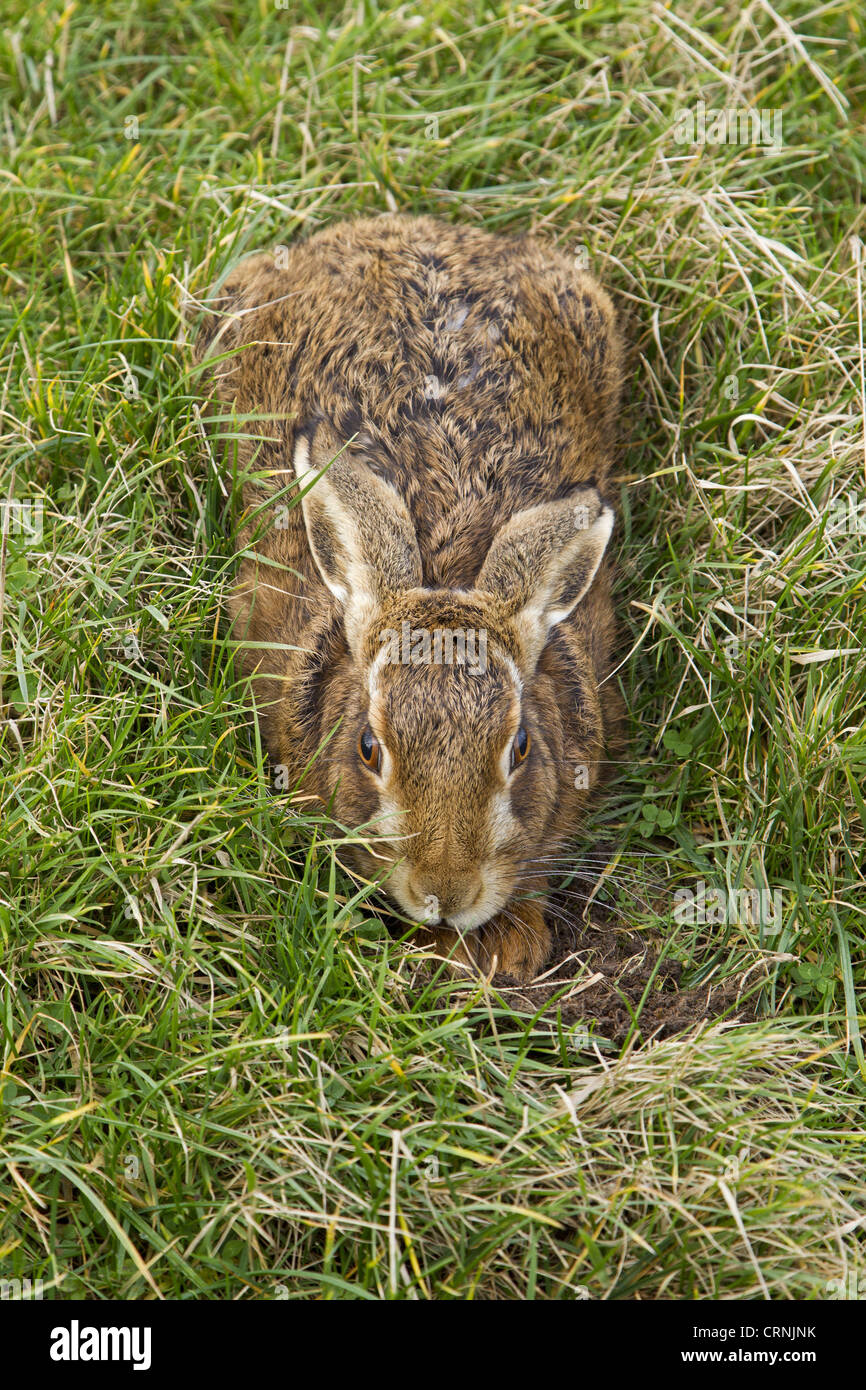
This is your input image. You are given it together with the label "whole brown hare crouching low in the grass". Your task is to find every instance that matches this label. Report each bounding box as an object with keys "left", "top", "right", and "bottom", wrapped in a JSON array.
[{"left": 196, "top": 215, "right": 623, "bottom": 980}]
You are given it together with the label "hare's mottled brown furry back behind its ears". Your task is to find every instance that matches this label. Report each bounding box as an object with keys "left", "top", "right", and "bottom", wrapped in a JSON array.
[{"left": 198, "top": 217, "right": 621, "bottom": 584}]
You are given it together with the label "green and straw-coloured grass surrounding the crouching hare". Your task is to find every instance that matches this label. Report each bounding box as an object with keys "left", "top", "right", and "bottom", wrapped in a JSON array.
[{"left": 0, "top": 0, "right": 866, "bottom": 1300}]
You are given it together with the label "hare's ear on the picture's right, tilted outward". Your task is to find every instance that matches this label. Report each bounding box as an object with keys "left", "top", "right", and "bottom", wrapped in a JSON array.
[{"left": 475, "top": 488, "right": 613, "bottom": 674}]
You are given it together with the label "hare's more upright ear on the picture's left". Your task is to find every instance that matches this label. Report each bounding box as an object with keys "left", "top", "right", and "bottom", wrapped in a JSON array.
[{"left": 293, "top": 423, "right": 421, "bottom": 655}]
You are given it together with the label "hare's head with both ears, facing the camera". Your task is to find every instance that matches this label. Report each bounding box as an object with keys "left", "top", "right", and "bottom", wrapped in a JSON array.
[{"left": 287, "top": 425, "right": 613, "bottom": 930}]
